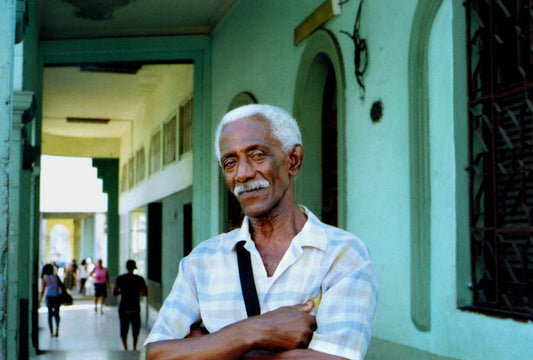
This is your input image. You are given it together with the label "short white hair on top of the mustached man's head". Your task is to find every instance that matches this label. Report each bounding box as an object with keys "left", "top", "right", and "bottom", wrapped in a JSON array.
[{"left": 215, "top": 104, "right": 303, "bottom": 161}]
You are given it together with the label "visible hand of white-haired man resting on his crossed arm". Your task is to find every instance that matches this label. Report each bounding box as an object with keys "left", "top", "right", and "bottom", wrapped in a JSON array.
[{"left": 248, "top": 301, "right": 316, "bottom": 351}]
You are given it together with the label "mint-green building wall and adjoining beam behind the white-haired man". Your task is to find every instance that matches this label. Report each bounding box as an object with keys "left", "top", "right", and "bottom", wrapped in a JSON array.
[{"left": 15, "top": 0, "right": 533, "bottom": 359}]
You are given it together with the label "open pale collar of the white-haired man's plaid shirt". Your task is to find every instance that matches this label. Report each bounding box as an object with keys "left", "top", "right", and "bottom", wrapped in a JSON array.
[{"left": 232, "top": 205, "right": 327, "bottom": 251}]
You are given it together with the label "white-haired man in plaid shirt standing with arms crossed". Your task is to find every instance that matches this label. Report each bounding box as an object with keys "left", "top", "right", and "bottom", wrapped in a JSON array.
[{"left": 145, "top": 104, "right": 377, "bottom": 360}]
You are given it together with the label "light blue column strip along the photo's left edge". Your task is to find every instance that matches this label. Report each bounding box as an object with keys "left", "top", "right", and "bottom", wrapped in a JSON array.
[{"left": 0, "top": 0, "right": 16, "bottom": 359}]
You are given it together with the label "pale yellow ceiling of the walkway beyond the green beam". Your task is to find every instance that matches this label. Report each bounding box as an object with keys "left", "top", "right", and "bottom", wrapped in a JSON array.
[{"left": 42, "top": 65, "right": 179, "bottom": 138}]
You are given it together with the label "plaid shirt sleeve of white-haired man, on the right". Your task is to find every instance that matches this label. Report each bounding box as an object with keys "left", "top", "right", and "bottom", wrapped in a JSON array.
[{"left": 309, "top": 238, "right": 377, "bottom": 359}]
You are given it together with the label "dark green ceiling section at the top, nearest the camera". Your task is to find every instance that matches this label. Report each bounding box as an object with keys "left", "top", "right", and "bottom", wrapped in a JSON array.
[{"left": 37, "top": 0, "right": 238, "bottom": 40}]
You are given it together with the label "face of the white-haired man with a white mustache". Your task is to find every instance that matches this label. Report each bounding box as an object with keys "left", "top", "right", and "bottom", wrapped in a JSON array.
[{"left": 219, "top": 116, "right": 292, "bottom": 217}]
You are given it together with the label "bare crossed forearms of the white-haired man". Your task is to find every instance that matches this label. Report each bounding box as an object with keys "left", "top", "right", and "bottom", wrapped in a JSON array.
[{"left": 146, "top": 301, "right": 350, "bottom": 360}]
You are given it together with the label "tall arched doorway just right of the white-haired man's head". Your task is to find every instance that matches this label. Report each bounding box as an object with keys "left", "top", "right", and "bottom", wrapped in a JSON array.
[{"left": 294, "top": 31, "right": 345, "bottom": 226}]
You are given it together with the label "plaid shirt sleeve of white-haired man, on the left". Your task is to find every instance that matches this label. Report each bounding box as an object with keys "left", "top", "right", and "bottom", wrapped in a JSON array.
[{"left": 144, "top": 258, "right": 200, "bottom": 346}]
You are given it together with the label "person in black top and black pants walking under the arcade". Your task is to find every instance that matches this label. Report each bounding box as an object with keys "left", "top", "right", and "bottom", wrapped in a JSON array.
[{"left": 113, "top": 260, "right": 148, "bottom": 350}]
